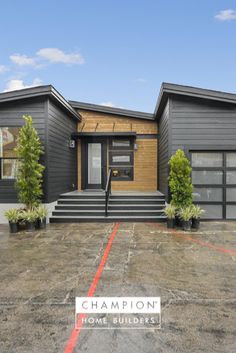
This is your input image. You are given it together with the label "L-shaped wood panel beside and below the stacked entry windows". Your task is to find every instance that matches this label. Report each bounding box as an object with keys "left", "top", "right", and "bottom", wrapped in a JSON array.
[{"left": 112, "top": 139, "right": 157, "bottom": 191}]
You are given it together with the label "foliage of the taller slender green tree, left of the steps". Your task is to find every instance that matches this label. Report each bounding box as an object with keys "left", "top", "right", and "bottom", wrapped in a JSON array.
[{"left": 16, "top": 115, "right": 44, "bottom": 209}]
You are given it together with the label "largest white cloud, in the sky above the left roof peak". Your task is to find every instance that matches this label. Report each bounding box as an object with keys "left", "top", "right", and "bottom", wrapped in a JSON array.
[{"left": 36, "top": 48, "right": 84, "bottom": 64}]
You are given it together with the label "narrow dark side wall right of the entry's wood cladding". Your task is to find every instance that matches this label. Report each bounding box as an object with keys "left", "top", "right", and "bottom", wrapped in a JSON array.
[{"left": 158, "top": 101, "right": 169, "bottom": 195}]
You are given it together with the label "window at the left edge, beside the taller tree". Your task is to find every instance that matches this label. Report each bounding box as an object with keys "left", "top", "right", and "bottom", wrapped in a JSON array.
[{"left": 0, "top": 127, "right": 20, "bottom": 179}]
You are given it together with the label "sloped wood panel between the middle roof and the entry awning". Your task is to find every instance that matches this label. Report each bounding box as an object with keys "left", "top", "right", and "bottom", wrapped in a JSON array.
[{"left": 78, "top": 110, "right": 158, "bottom": 134}]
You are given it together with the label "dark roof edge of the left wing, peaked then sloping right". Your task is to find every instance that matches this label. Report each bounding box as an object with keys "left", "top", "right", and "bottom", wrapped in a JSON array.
[{"left": 0, "top": 85, "right": 81, "bottom": 121}]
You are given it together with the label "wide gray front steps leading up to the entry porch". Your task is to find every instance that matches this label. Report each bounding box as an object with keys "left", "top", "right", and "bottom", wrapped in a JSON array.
[{"left": 50, "top": 192, "right": 166, "bottom": 223}]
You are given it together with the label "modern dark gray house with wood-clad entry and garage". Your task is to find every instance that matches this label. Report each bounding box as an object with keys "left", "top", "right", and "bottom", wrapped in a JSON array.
[{"left": 0, "top": 83, "right": 236, "bottom": 222}]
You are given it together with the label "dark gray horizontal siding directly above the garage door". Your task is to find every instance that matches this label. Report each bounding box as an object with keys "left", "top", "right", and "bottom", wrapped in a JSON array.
[{"left": 170, "top": 96, "right": 236, "bottom": 153}]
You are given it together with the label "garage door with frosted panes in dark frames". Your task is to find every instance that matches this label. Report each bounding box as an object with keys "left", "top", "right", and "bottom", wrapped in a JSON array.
[{"left": 191, "top": 151, "right": 236, "bottom": 219}]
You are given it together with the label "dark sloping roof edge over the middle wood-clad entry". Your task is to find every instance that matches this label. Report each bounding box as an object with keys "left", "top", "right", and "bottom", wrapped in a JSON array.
[{"left": 69, "top": 100, "right": 155, "bottom": 120}]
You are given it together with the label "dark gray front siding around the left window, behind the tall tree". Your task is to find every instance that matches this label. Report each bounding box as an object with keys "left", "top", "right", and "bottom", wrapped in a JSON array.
[{"left": 0, "top": 98, "right": 45, "bottom": 203}]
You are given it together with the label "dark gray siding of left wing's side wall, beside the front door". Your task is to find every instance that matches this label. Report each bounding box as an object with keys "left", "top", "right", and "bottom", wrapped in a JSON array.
[{"left": 46, "top": 101, "right": 77, "bottom": 202}]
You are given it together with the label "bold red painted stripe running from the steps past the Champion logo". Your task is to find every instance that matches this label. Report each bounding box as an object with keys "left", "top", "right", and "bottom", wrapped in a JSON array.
[{"left": 64, "top": 223, "right": 119, "bottom": 353}]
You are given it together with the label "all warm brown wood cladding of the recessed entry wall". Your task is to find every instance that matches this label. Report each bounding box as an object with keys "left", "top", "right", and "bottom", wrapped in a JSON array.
[{"left": 78, "top": 111, "right": 158, "bottom": 191}]
